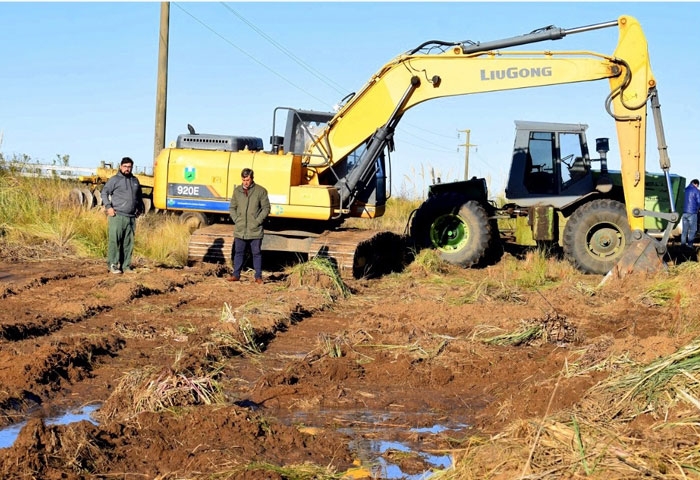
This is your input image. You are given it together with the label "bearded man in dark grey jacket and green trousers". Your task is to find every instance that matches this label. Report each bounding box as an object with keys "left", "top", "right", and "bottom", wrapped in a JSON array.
[{"left": 102, "top": 157, "right": 145, "bottom": 274}]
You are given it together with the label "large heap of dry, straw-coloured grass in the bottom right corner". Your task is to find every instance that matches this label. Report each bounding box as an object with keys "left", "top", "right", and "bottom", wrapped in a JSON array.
[{"left": 440, "top": 339, "right": 700, "bottom": 480}]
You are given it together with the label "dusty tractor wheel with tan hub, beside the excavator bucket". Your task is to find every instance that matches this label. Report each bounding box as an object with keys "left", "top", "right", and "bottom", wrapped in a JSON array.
[{"left": 563, "top": 199, "right": 632, "bottom": 275}]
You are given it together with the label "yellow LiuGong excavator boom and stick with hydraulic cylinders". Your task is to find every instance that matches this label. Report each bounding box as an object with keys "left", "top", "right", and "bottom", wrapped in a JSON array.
[{"left": 307, "top": 16, "right": 674, "bottom": 238}]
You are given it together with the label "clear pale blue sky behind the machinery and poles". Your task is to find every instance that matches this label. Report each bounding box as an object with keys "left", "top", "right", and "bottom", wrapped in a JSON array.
[{"left": 0, "top": 2, "right": 700, "bottom": 196}]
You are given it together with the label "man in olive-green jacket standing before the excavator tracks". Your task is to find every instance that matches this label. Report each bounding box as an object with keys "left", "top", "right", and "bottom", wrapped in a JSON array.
[{"left": 228, "top": 168, "right": 270, "bottom": 283}]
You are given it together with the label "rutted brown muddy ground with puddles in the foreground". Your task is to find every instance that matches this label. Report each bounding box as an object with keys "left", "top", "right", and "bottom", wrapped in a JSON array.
[{"left": 0, "top": 246, "right": 690, "bottom": 479}]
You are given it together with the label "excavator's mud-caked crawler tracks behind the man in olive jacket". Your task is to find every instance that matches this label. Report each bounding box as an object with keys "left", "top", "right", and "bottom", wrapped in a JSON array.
[{"left": 188, "top": 224, "right": 406, "bottom": 278}]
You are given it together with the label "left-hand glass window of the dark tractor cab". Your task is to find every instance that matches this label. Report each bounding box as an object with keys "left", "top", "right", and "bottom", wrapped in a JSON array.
[{"left": 525, "top": 132, "right": 556, "bottom": 194}]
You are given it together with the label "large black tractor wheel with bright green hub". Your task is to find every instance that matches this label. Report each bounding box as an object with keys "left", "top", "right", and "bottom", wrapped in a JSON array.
[{"left": 411, "top": 193, "right": 491, "bottom": 267}]
